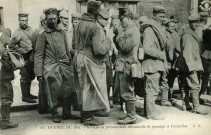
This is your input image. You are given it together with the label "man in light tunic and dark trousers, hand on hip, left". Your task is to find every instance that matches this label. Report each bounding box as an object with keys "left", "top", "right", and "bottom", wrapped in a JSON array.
[{"left": 9, "top": 13, "right": 38, "bottom": 103}]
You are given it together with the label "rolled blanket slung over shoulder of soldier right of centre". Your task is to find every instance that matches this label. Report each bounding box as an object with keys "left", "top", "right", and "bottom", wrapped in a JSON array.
[{"left": 141, "top": 20, "right": 166, "bottom": 50}]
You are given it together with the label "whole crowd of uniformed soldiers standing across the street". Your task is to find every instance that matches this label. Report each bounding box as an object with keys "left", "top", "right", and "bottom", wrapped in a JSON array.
[{"left": 0, "top": 0, "right": 211, "bottom": 129}]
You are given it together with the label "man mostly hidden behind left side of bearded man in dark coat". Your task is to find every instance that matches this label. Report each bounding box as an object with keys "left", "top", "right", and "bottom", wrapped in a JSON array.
[{"left": 32, "top": 14, "right": 49, "bottom": 114}]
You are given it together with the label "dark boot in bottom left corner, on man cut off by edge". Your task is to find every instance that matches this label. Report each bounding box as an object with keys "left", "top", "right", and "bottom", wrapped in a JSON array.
[{"left": 0, "top": 105, "right": 18, "bottom": 129}]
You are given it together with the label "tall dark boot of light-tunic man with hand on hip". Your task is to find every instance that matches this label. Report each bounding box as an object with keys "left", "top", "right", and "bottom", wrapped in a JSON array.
[{"left": 20, "top": 80, "right": 36, "bottom": 103}]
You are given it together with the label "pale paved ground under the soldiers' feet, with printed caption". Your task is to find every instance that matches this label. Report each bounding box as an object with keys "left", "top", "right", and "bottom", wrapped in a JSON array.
[{"left": 0, "top": 70, "right": 211, "bottom": 135}]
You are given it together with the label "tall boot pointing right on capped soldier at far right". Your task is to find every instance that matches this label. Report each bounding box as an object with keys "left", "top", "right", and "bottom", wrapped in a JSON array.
[{"left": 192, "top": 91, "right": 208, "bottom": 115}]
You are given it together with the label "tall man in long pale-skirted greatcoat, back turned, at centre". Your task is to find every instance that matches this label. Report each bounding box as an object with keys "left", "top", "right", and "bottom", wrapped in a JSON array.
[{"left": 73, "top": 0, "right": 111, "bottom": 126}]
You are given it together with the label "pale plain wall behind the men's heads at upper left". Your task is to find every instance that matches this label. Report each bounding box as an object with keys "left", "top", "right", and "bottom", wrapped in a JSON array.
[{"left": 0, "top": 0, "right": 76, "bottom": 32}]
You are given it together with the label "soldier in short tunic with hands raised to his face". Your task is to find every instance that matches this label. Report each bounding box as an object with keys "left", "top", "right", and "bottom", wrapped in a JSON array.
[{"left": 114, "top": 8, "right": 140, "bottom": 124}]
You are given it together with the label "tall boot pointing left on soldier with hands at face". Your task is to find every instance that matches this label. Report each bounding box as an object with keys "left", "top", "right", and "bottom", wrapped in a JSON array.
[{"left": 118, "top": 101, "right": 136, "bottom": 125}]
